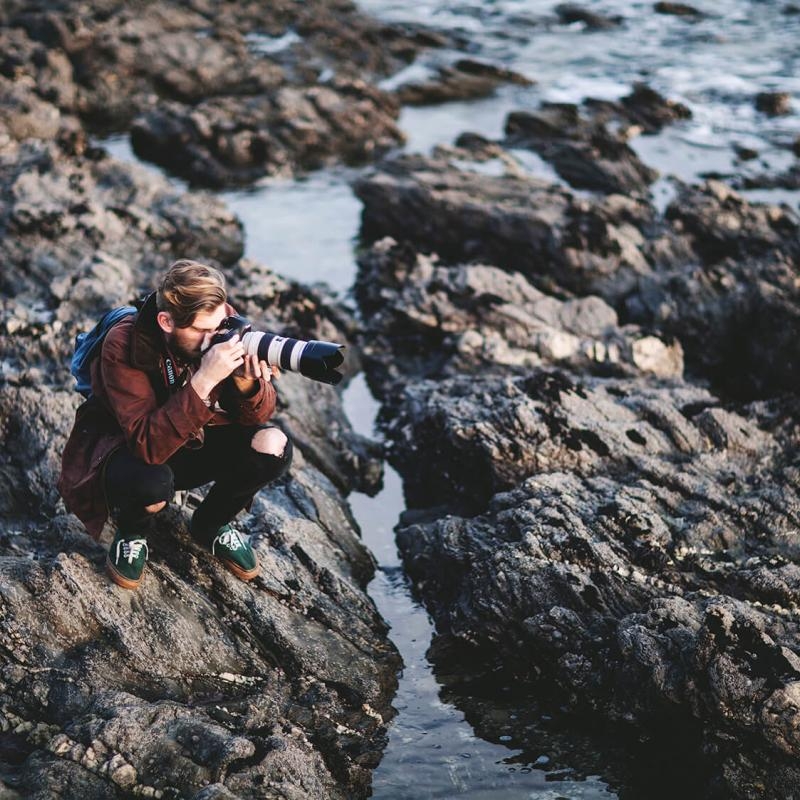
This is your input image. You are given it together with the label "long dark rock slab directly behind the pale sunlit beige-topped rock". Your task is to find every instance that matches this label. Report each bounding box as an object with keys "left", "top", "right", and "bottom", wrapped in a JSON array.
[{"left": 355, "top": 157, "right": 654, "bottom": 296}]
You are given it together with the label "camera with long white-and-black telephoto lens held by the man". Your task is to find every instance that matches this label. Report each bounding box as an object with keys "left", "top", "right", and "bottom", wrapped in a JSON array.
[{"left": 209, "top": 315, "right": 344, "bottom": 386}]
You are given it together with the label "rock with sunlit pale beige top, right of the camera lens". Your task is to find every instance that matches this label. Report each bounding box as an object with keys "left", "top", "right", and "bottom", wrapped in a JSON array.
[{"left": 356, "top": 239, "right": 683, "bottom": 396}]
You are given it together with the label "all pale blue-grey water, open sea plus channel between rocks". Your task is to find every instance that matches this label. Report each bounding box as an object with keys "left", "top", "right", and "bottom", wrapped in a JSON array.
[{"left": 104, "top": 0, "right": 800, "bottom": 800}]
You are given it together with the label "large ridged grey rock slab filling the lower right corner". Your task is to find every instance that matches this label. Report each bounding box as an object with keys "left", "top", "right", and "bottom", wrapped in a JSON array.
[{"left": 398, "top": 446, "right": 800, "bottom": 797}]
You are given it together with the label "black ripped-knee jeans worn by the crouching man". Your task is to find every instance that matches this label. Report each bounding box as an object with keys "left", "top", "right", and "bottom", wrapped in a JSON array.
[{"left": 104, "top": 425, "right": 292, "bottom": 538}]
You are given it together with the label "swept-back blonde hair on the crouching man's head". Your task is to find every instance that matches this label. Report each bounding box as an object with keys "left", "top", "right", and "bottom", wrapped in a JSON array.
[{"left": 156, "top": 258, "right": 228, "bottom": 328}]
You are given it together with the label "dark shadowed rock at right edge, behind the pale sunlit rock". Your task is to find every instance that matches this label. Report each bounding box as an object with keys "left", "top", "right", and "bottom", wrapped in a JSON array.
[{"left": 636, "top": 182, "right": 800, "bottom": 398}]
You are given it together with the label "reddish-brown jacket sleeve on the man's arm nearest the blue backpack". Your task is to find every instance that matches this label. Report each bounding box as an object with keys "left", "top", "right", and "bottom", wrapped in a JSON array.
[{"left": 100, "top": 326, "right": 214, "bottom": 464}]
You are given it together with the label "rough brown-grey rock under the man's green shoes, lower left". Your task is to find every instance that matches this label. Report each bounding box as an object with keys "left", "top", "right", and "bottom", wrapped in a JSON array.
[{"left": 0, "top": 432, "right": 398, "bottom": 798}]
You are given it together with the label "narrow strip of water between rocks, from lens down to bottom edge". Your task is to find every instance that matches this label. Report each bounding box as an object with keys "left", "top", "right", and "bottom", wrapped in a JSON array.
[{"left": 344, "top": 376, "right": 614, "bottom": 800}]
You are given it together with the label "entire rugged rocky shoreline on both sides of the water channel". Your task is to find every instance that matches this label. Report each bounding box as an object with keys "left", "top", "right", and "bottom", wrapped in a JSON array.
[{"left": 0, "top": 0, "right": 800, "bottom": 800}]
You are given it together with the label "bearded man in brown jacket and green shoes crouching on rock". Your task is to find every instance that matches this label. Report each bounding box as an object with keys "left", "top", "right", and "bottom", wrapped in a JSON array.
[{"left": 58, "top": 260, "right": 292, "bottom": 589}]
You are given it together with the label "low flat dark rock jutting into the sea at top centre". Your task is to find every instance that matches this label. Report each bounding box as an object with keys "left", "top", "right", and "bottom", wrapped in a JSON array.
[{"left": 396, "top": 59, "right": 533, "bottom": 106}]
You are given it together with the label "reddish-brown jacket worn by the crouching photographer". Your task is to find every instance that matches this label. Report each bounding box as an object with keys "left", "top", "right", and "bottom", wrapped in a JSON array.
[{"left": 58, "top": 294, "right": 275, "bottom": 539}]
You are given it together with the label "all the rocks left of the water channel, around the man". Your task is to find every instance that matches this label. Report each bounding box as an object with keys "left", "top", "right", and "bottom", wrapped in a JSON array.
[{"left": 0, "top": 2, "right": 412, "bottom": 800}]
